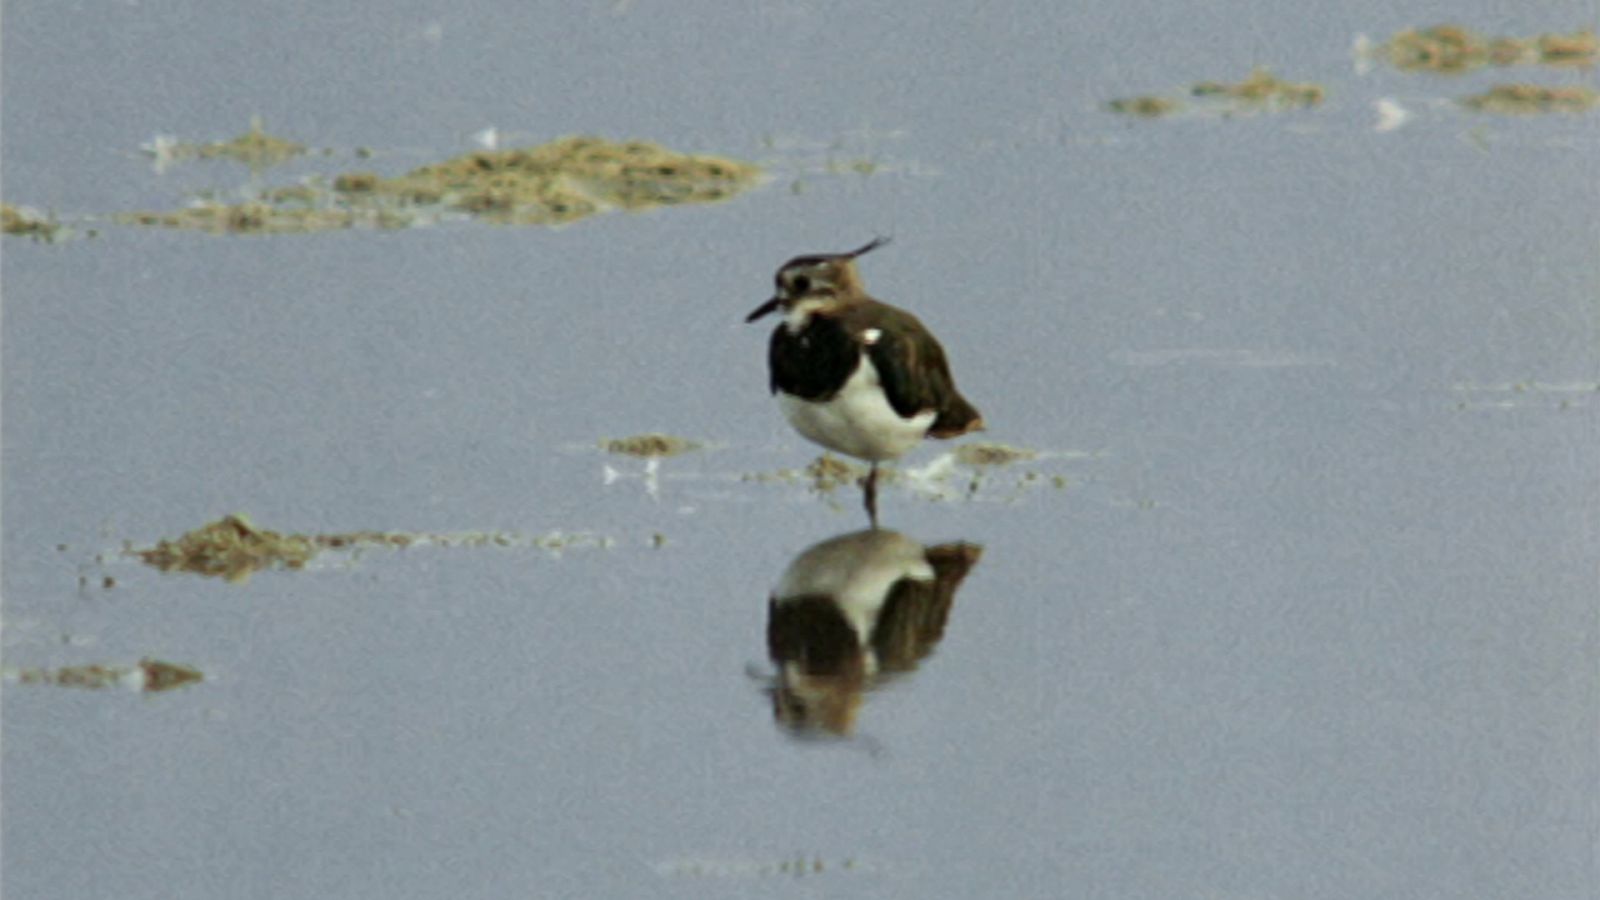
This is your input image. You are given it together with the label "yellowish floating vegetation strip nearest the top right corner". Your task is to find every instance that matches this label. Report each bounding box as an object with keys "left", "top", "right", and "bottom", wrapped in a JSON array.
[{"left": 1378, "top": 24, "right": 1600, "bottom": 72}]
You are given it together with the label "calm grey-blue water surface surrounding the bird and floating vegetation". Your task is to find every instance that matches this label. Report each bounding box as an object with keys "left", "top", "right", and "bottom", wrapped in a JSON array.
[{"left": 0, "top": 0, "right": 1600, "bottom": 900}]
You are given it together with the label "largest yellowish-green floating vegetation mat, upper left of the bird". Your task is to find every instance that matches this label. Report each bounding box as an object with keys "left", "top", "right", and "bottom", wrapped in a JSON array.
[{"left": 117, "top": 135, "right": 762, "bottom": 234}]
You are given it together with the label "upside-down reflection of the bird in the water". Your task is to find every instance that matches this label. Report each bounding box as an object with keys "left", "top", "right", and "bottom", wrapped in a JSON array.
[{"left": 766, "top": 528, "right": 982, "bottom": 737}]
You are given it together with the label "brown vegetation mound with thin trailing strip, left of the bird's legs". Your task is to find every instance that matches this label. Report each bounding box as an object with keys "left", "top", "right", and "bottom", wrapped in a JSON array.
[{"left": 131, "top": 514, "right": 613, "bottom": 583}]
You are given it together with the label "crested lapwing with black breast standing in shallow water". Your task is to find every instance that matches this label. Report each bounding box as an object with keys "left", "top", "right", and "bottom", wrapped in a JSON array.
[{"left": 744, "top": 237, "right": 984, "bottom": 527}]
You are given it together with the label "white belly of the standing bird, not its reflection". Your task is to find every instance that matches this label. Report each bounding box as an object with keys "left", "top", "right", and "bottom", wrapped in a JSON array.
[{"left": 778, "top": 356, "right": 938, "bottom": 463}]
